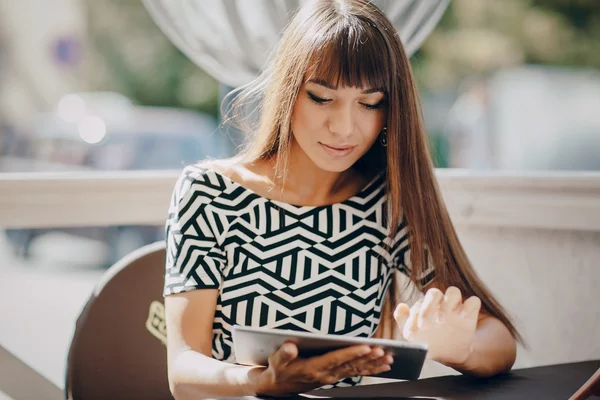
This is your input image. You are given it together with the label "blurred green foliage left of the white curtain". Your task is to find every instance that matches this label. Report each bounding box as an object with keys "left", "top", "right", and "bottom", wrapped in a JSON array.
[{"left": 82, "top": 0, "right": 219, "bottom": 116}]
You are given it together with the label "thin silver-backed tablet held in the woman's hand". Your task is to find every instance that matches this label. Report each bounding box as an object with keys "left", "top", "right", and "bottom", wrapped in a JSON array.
[{"left": 232, "top": 325, "right": 427, "bottom": 380}]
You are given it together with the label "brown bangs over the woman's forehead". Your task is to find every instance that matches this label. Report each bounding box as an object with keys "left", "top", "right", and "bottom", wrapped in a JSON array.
[{"left": 307, "top": 17, "right": 392, "bottom": 92}]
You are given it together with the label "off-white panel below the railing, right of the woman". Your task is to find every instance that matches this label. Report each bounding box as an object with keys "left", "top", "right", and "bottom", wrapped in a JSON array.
[{"left": 423, "top": 226, "right": 600, "bottom": 376}]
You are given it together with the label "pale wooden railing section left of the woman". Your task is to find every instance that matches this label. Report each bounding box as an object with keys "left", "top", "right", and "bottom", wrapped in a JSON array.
[{"left": 0, "top": 171, "right": 179, "bottom": 228}]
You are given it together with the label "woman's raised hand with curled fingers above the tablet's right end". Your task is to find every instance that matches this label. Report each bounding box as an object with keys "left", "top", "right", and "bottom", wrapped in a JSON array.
[{"left": 394, "top": 286, "right": 481, "bottom": 366}]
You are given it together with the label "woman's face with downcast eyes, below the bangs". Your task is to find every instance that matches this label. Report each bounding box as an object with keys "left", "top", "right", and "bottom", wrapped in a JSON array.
[{"left": 292, "top": 76, "right": 387, "bottom": 172}]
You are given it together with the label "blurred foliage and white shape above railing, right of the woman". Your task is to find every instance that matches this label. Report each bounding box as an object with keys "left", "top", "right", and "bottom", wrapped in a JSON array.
[{"left": 413, "top": 0, "right": 600, "bottom": 170}]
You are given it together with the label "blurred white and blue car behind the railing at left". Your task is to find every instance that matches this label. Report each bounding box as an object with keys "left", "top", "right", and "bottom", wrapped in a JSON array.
[{"left": 6, "top": 93, "right": 234, "bottom": 267}]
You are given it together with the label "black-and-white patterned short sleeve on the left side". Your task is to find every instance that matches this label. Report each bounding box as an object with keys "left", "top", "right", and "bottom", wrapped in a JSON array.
[{"left": 163, "top": 167, "right": 226, "bottom": 296}]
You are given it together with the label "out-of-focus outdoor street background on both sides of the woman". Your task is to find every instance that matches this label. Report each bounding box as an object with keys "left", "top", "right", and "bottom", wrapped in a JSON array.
[{"left": 0, "top": 0, "right": 600, "bottom": 398}]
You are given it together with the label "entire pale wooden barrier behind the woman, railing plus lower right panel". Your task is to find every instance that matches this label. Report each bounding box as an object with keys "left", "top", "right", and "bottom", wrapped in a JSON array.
[{"left": 0, "top": 170, "right": 600, "bottom": 377}]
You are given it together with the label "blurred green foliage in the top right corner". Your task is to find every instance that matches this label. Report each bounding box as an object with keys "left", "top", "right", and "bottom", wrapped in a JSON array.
[{"left": 413, "top": 0, "right": 600, "bottom": 90}]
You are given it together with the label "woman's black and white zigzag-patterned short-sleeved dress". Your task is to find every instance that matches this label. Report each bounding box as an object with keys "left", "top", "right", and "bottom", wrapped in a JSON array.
[{"left": 164, "top": 166, "right": 428, "bottom": 386}]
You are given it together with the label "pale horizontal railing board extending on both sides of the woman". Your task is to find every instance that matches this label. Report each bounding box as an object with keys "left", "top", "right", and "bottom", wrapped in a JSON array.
[{"left": 0, "top": 169, "right": 600, "bottom": 231}]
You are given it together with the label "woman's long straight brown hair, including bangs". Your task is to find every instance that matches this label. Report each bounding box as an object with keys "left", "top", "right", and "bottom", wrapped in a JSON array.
[{"left": 223, "top": 0, "right": 522, "bottom": 342}]
